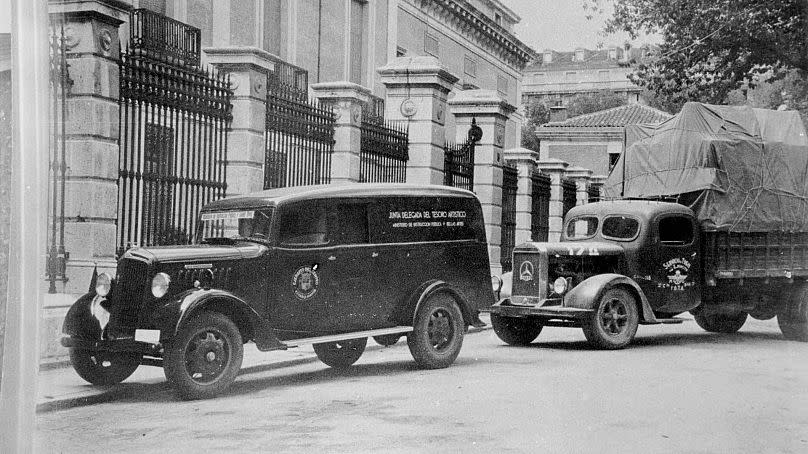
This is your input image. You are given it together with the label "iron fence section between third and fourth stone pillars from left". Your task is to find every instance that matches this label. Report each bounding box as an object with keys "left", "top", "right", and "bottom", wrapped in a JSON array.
[{"left": 359, "top": 96, "right": 410, "bottom": 183}]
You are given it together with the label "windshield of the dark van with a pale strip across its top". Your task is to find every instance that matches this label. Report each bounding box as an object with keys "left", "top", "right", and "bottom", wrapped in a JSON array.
[{"left": 197, "top": 208, "right": 272, "bottom": 243}]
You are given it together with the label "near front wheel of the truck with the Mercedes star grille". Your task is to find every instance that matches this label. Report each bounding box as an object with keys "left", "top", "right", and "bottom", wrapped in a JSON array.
[{"left": 583, "top": 288, "right": 640, "bottom": 350}]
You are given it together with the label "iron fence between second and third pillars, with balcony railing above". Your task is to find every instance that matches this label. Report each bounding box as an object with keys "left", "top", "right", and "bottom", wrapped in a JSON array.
[{"left": 264, "top": 60, "right": 336, "bottom": 189}]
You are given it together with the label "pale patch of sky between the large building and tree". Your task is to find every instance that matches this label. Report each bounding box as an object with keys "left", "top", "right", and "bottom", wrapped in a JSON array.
[{"left": 501, "top": 0, "right": 655, "bottom": 52}]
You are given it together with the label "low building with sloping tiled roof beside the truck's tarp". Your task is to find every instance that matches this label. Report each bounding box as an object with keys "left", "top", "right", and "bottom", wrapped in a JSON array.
[{"left": 536, "top": 103, "right": 672, "bottom": 175}]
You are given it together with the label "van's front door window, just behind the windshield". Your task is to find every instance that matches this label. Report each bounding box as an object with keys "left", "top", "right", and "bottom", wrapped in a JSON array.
[{"left": 279, "top": 202, "right": 329, "bottom": 246}]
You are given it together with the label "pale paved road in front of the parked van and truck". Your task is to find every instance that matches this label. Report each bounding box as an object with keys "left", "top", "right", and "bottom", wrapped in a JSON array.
[{"left": 36, "top": 319, "right": 808, "bottom": 453}]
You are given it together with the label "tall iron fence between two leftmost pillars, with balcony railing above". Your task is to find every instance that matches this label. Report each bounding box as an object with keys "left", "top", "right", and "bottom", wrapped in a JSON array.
[{"left": 117, "top": 9, "right": 233, "bottom": 255}]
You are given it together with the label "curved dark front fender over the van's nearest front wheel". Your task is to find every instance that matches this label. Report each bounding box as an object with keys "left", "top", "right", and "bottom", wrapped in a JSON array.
[{"left": 152, "top": 289, "right": 286, "bottom": 351}]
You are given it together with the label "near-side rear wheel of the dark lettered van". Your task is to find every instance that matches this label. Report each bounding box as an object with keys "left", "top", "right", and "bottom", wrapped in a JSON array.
[{"left": 407, "top": 293, "right": 465, "bottom": 369}]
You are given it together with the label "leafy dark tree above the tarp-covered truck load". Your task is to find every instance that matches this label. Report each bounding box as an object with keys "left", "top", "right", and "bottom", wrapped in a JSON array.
[{"left": 584, "top": 0, "right": 808, "bottom": 105}]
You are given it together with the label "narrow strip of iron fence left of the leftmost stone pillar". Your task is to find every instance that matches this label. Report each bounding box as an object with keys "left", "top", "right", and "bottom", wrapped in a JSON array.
[{"left": 46, "top": 24, "right": 73, "bottom": 293}]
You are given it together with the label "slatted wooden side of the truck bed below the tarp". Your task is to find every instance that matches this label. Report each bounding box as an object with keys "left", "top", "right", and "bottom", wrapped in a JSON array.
[{"left": 702, "top": 232, "right": 808, "bottom": 279}]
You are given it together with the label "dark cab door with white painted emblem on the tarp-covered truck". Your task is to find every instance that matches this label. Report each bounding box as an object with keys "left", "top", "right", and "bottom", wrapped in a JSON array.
[{"left": 644, "top": 214, "right": 701, "bottom": 314}]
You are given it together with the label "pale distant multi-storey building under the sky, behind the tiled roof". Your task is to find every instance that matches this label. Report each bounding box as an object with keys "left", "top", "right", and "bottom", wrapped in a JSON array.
[{"left": 522, "top": 45, "right": 654, "bottom": 106}]
